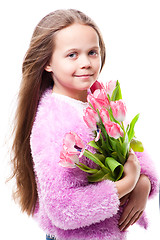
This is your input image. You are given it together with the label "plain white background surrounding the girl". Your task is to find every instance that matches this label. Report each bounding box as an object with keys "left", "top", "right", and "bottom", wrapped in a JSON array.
[{"left": 0, "top": 0, "right": 160, "bottom": 240}]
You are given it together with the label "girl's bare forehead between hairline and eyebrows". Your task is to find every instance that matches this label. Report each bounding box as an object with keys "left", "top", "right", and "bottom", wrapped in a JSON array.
[{"left": 55, "top": 23, "right": 99, "bottom": 49}]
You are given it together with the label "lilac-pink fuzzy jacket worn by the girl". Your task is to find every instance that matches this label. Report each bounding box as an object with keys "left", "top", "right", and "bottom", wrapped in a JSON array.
[{"left": 30, "top": 90, "right": 158, "bottom": 240}]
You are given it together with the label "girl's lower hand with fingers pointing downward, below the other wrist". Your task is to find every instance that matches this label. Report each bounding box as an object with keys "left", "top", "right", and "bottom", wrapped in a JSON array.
[{"left": 119, "top": 175, "right": 151, "bottom": 231}]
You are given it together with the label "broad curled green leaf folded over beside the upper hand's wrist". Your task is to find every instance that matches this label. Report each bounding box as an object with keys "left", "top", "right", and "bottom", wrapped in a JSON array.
[{"left": 105, "top": 157, "right": 123, "bottom": 181}]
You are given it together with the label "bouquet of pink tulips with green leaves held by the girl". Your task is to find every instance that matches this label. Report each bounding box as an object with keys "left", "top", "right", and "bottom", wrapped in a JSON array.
[{"left": 59, "top": 81, "right": 144, "bottom": 182}]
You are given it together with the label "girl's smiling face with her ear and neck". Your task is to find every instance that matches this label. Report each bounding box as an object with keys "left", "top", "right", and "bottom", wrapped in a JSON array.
[{"left": 45, "top": 23, "right": 101, "bottom": 101}]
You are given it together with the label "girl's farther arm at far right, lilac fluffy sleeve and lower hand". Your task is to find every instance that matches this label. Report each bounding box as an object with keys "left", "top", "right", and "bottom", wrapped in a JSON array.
[{"left": 119, "top": 152, "right": 158, "bottom": 230}]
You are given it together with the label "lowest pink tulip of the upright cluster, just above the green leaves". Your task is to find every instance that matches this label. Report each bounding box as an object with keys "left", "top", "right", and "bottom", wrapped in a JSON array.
[{"left": 104, "top": 121, "right": 123, "bottom": 139}]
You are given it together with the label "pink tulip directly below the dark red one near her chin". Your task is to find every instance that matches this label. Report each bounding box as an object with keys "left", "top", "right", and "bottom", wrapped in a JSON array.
[{"left": 87, "top": 89, "right": 109, "bottom": 110}]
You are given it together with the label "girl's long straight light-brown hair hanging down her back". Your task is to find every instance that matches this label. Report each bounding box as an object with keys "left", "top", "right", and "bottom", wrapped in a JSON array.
[{"left": 12, "top": 9, "right": 105, "bottom": 215}]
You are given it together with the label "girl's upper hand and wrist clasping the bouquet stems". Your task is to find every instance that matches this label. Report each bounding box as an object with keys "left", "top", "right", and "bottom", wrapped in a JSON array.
[{"left": 115, "top": 152, "right": 140, "bottom": 199}]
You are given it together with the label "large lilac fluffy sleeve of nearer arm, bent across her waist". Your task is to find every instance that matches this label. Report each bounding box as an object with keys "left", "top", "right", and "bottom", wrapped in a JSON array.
[{"left": 30, "top": 92, "right": 119, "bottom": 230}]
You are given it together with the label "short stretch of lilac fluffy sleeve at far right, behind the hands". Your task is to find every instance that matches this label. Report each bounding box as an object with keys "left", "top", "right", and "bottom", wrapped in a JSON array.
[{"left": 136, "top": 150, "right": 158, "bottom": 198}]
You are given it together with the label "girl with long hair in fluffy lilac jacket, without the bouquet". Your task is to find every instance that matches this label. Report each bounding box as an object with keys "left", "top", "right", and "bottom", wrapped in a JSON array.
[{"left": 13, "top": 10, "right": 158, "bottom": 240}]
